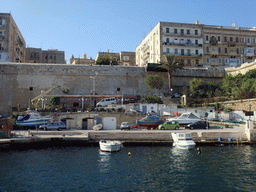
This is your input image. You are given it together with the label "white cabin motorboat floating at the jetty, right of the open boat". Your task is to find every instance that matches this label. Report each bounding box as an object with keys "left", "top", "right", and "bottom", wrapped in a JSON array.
[{"left": 172, "top": 133, "right": 196, "bottom": 149}]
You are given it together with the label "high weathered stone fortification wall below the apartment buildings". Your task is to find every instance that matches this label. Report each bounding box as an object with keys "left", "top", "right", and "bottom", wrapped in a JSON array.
[{"left": 0, "top": 63, "right": 225, "bottom": 114}]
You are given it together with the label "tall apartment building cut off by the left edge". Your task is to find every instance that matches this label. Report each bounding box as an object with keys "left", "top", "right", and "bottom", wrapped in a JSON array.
[{"left": 0, "top": 13, "right": 26, "bottom": 62}]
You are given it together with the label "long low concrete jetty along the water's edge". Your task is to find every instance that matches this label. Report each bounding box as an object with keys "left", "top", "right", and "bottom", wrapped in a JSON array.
[{"left": 0, "top": 126, "right": 254, "bottom": 148}]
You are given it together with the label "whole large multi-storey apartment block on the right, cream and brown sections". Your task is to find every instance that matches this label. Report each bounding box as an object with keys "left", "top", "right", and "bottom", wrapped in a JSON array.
[{"left": 136, "top": 21, "right": 256, "bottom": 68}]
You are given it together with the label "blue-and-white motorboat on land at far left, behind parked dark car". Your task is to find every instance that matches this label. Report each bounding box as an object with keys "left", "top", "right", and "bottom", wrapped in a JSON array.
[{"left": 16, "top": 112, "right": 52, "bottom": 127}]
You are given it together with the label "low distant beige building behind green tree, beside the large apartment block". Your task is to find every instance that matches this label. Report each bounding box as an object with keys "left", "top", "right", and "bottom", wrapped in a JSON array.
[{"left": 96, "top": 51, "right": 136, "bottom": 66}]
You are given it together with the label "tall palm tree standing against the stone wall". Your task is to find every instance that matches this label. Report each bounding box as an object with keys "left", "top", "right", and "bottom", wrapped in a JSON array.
[{"left": 161, "top": 55, "right": 184, "bottom": 94}]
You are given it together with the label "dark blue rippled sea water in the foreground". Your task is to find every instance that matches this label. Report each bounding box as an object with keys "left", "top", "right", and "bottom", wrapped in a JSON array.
[{"left": 0, "top": 146, "right": 256, "bottom": 192}]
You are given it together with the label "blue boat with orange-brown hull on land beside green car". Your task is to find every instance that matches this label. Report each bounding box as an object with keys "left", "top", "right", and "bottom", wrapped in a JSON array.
[{"left": 136, "top": 116, "right": 164, "bottom": 128}]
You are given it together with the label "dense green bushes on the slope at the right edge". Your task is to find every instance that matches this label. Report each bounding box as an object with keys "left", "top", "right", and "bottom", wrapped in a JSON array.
[{"left": 187, "top": 69, "right": 256, "bottom": 106}]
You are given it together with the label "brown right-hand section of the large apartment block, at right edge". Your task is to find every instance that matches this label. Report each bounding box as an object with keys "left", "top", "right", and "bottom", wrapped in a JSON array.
[{"left": 203, "top": 25, "right": 256, "bottom": 68}]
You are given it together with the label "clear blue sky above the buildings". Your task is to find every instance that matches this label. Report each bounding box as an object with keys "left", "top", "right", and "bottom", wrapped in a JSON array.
[{"left": 0, "top": 0, "right": 256, "bottom": 63}]
